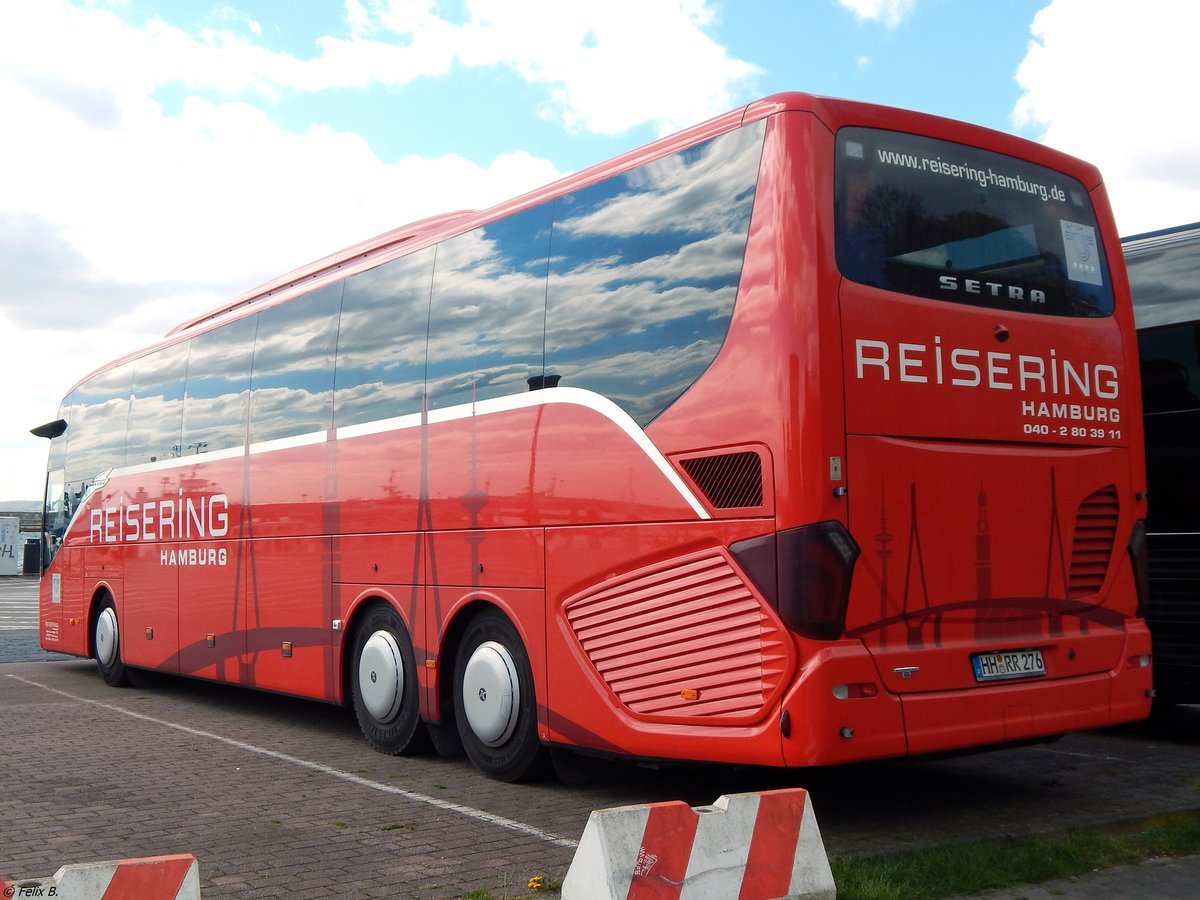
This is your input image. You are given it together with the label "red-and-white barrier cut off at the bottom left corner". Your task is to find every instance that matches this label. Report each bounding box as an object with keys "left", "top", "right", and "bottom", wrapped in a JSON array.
[{"left": 6, "top": 853, "right": 200, "bottom": 900}]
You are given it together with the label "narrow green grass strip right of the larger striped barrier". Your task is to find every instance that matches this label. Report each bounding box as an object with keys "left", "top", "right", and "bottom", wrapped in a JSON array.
[{"left": 829, "top": 810, "right": 1200, "bottom": 900}]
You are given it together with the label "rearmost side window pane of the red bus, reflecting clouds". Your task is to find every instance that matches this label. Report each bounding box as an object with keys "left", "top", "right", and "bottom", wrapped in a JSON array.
[{"left": 546, "top": 124, "right": 764, "bottom": 425}]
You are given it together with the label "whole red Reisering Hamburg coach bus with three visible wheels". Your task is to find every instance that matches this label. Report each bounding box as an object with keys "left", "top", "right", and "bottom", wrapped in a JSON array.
[{"left": 35, "top": 94, "right": 1151, "bottom": 780}]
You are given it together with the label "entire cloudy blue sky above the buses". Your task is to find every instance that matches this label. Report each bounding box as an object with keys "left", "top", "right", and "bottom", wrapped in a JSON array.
[{"left": 0, "top": 0, "right": 1200, "bottom": 499}]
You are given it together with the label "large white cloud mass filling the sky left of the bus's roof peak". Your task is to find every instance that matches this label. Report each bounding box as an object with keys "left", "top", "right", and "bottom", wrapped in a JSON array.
[{"left": 0, "top": 0, "right": 758, "bottom": 499}]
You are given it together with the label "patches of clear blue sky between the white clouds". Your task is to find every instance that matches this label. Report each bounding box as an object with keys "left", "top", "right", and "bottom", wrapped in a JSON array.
[{"left": 108, "top": 0, "right": 1045, "bottom": 169}]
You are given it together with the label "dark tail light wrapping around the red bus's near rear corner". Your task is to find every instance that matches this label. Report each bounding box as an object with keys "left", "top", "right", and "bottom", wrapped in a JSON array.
[{"left": 730, "top": 522, "right": 859, "bottom": 640}]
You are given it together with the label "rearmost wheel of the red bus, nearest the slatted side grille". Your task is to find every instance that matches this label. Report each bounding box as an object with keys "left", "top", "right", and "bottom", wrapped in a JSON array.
[{"left": 454, "top": 610, "right": 546, "bottom": 781}]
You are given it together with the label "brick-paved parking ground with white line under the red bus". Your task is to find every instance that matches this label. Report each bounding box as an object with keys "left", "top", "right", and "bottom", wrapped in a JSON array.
[{"left": 0, "top": 573, "right": 1200, "bottom": 900}]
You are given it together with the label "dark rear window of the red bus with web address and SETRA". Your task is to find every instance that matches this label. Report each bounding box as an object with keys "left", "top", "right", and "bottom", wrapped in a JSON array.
[{"left": 835, "top": 128, "right": 1112, "bottom": 317}]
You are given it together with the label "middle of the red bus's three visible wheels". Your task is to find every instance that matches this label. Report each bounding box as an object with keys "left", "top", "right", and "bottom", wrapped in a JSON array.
[{"left": 353, "top": 605, "right": 420, "bottom": 755}]
